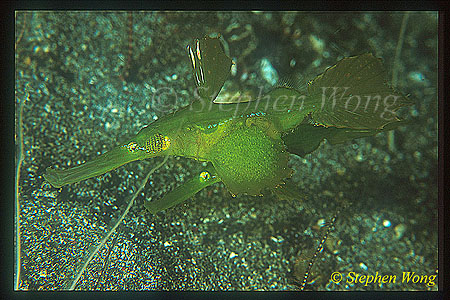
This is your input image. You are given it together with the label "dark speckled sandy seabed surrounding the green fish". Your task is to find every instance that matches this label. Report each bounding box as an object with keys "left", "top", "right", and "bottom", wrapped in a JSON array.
[{"left": 15, "top": 11, "right": 438, "bottom": 291}]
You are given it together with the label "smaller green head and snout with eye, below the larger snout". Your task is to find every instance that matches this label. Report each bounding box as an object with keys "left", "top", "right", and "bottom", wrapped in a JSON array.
[{"left": 144, "top": 168, "right": 220, "bottom": 214}]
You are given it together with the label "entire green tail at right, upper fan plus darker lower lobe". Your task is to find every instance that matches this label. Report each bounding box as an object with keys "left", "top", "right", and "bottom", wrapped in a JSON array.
[{"left": 282, "top": 54, "right": 413, "bottom": 156}]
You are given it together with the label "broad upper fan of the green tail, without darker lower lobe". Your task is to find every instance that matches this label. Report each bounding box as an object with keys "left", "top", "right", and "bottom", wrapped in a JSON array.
[{"left": 308, "top": 54, "right": 412, "bottom": 129}]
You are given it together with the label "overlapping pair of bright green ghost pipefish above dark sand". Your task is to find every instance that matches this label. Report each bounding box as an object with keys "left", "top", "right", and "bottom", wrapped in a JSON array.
[{"left": 44, "top": 36, "right": 412, "bottom": 213}]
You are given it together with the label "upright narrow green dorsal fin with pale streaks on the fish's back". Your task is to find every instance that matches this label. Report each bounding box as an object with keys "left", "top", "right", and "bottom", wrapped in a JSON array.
[{"left": 187, "top": 36, "right": 233, "bottom": 101}]
